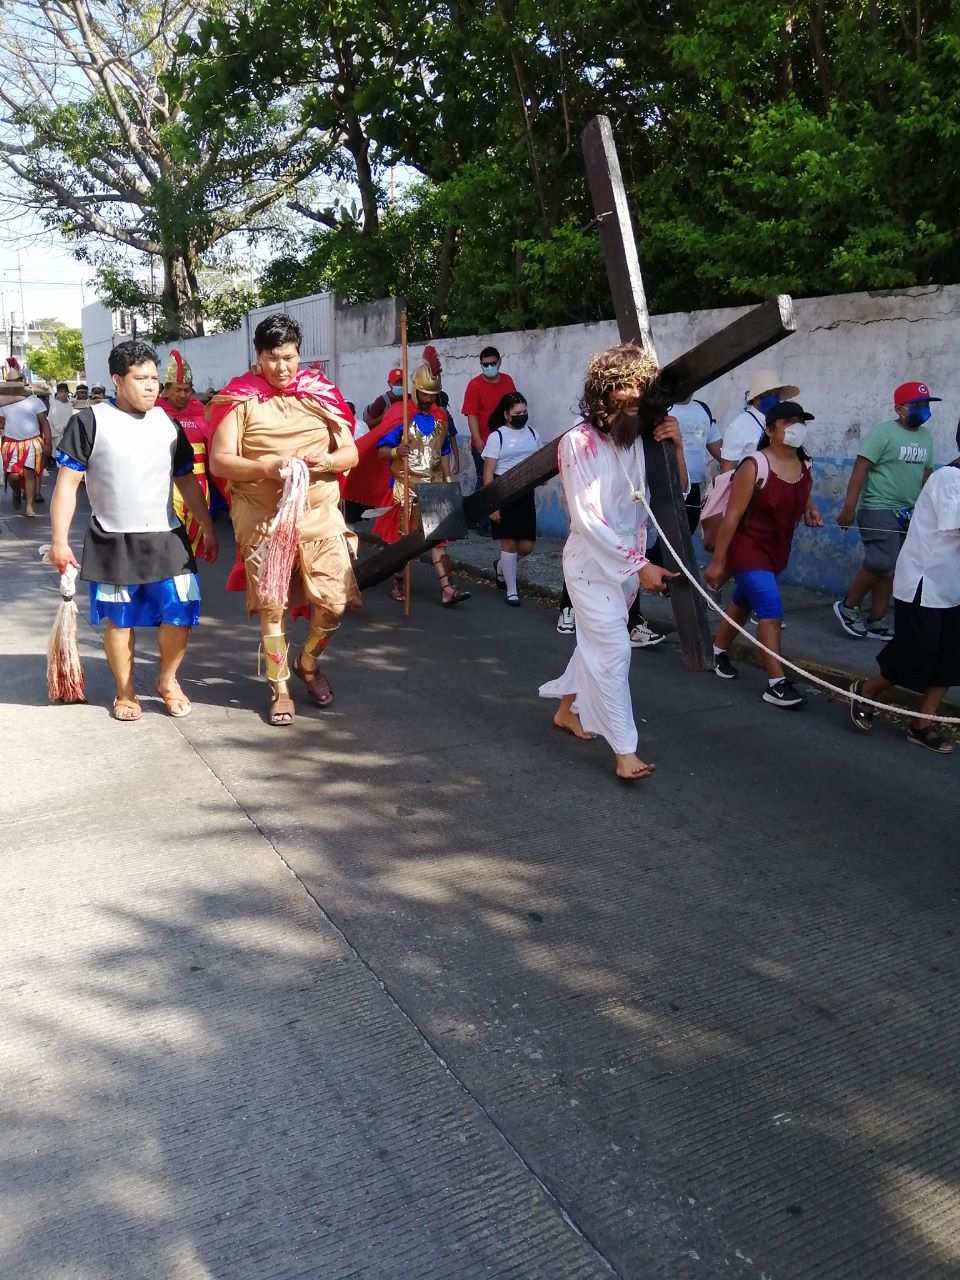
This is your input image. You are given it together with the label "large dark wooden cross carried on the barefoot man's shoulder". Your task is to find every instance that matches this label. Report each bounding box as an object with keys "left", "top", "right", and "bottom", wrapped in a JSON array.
[{"left": 357, "top": 115, "right": 796, "bottom": 671}]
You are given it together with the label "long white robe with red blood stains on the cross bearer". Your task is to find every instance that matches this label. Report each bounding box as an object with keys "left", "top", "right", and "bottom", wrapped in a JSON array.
[{"left": 540, "top": 422, "right": 648, "bottom": 755}]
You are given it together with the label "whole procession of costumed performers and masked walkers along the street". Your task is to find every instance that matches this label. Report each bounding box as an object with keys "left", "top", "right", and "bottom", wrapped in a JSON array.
[{"left": 0, "top": 314, "right": 960, "bottom": 781}]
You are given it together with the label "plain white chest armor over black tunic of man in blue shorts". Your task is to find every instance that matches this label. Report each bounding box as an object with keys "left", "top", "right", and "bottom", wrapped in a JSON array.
[{"left": 86, "top": 404, "right": 178, "bottom": 534}]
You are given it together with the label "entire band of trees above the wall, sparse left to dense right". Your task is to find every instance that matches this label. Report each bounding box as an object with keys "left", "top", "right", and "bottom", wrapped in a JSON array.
[{"left": 13, "top": 0, "right": 960, "bottom": 335}]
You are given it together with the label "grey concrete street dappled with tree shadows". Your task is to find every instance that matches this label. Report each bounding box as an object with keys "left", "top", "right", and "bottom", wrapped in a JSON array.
[{"left": 0, "top": 484, "right": 960, "bottom": 1280}]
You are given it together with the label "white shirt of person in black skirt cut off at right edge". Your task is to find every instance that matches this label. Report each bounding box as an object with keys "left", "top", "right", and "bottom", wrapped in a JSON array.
[{"left": 893, "top": 467, "right": 960, "bottom": 609}]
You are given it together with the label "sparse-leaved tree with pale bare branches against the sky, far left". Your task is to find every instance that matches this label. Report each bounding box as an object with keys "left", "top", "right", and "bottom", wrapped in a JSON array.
[{"left": 0, "top": 0, "right": 335, "bottom": 337}]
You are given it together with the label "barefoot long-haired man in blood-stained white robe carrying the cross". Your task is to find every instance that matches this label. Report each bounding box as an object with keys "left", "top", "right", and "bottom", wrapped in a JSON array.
[{"left": 540, "top": 343, "right": 687, "bottom": 782}]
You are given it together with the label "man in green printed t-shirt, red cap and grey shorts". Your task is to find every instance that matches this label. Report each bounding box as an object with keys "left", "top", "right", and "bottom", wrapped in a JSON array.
[{"left": 833, "top": 383, "right": 940, "bottom": 641}]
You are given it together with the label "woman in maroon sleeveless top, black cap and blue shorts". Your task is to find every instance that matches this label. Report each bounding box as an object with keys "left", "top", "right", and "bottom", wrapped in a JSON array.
[{"left": 704, "top": 401, "right": 823, "bottom": 707}]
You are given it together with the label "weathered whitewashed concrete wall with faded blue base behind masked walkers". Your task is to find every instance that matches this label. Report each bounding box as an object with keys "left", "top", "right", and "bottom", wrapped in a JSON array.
[{"left": 337, "top": 285, "right": 960, "bottom": 591}]
